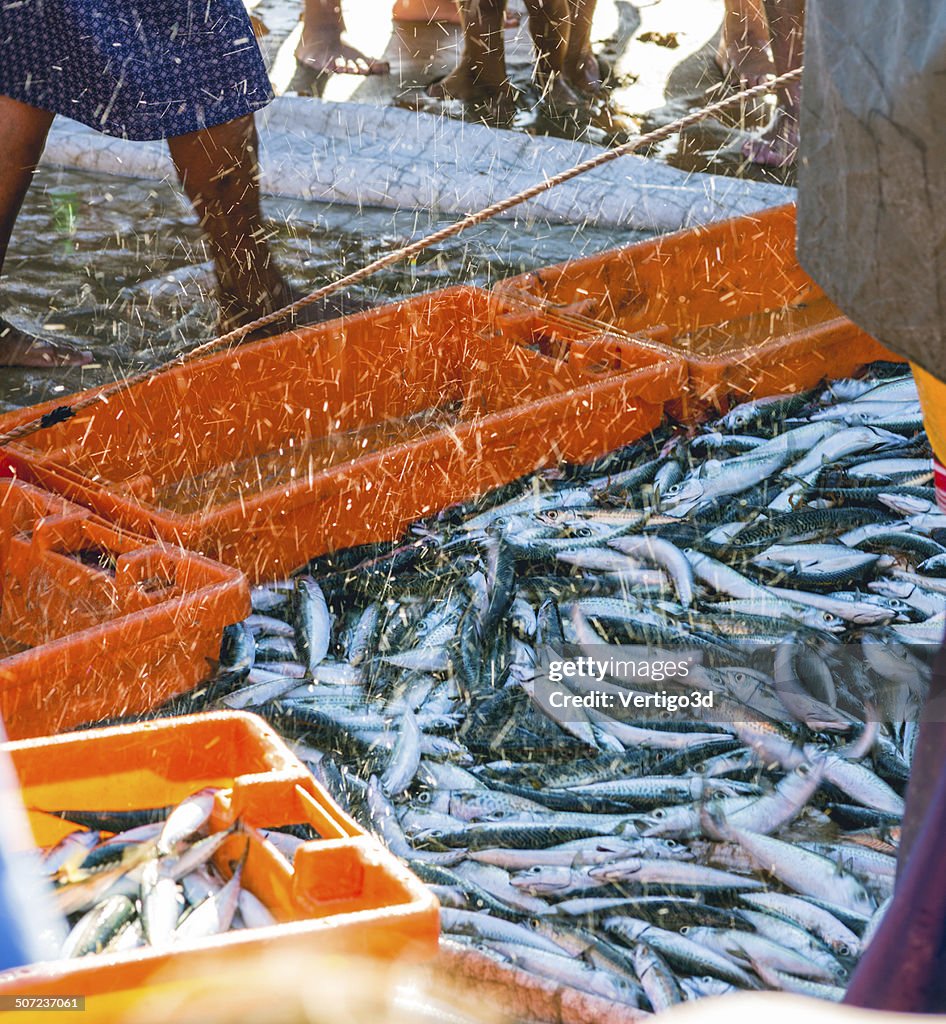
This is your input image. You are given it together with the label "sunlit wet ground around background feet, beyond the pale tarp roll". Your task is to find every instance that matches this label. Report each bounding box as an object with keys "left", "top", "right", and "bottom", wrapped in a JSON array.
[{"left": 256, "top": 0, "right": 793, "bottom": 184}]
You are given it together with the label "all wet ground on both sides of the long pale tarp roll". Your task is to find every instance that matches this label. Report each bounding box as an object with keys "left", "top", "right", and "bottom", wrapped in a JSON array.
[{"left": 0, "top": 0, "right": 790, "bottom": 406}]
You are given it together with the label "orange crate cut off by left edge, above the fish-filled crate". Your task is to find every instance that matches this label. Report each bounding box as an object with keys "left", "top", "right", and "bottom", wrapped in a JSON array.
[{"left": 0, "top": 480, "right": 250, "bottom": 738}]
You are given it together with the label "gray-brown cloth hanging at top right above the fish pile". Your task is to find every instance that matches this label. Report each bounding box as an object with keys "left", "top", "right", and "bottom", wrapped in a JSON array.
[{"left": 799, "top": 0, "right": 946, "bottom": 379}]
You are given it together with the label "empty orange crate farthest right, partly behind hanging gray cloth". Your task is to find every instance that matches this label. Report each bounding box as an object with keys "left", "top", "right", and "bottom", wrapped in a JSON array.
[{"left": 493, "top": 205, "right": 898, "bottom": 409}]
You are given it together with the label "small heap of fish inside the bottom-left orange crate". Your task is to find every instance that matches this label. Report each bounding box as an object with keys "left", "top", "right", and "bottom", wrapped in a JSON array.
[{"left": 40, "top": 788, "right": 275, "bottom": 958}]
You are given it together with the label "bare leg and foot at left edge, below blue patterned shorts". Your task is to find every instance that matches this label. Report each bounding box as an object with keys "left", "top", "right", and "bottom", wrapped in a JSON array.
[{"left": 0, "top": 96, "right": 92, "bottom": 367}]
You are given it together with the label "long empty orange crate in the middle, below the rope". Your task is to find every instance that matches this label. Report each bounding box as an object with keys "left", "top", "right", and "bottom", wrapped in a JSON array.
[{"left": 0, "top": 288, "right": 686, "bottom": 579}]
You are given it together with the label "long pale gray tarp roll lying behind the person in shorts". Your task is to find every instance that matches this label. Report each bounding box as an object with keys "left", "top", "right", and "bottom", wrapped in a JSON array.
[{"left": 40, "top": 95, "right": 793, "bottom": 232}]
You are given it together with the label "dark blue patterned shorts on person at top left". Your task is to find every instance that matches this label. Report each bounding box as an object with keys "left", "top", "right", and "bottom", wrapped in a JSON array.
[{"left": 0, "top": 0, "right": 272, "bottom": 139}]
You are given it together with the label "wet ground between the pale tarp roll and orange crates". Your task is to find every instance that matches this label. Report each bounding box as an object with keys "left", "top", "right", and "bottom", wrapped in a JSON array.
[{"left": 0, "top": 168, "right": 643, "bottom": 408}]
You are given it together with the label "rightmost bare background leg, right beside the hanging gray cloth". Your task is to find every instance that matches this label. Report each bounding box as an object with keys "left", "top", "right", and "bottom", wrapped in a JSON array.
[{"left": 742, "top": 0, "right": 805, "bottom": 167}]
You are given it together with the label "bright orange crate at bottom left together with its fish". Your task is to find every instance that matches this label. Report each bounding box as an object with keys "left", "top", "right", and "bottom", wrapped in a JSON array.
[{"left": 0, "top": 713, "right": 437, "bottom": 1020}]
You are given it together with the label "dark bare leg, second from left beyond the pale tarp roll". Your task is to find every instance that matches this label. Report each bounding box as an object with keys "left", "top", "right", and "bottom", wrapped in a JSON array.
[{"left": 427, "top": 0, "right": 512, "bottom": 103}]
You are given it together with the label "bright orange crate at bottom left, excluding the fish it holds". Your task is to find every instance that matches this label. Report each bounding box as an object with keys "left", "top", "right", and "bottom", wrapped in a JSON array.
[{"left": 0, "top": 712, "right": 439, "bottom": 1021}]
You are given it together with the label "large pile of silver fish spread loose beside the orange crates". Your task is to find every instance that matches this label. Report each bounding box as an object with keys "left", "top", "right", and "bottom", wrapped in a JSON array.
[{"left": 153, "top": 365, "right": 946, "bottom": 1011}]
